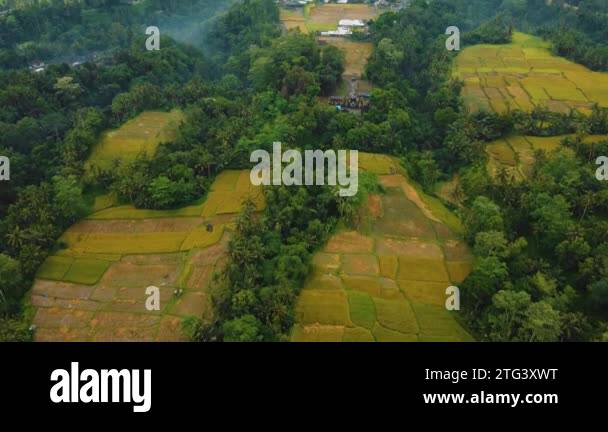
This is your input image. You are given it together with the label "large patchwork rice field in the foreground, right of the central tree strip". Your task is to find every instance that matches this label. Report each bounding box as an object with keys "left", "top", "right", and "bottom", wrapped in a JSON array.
[{"left": 291, "top": 153, "right": 473, "bottom": 342}]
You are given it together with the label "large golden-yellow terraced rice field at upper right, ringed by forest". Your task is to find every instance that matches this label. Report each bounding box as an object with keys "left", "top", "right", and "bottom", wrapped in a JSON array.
[{"left": 454, "top": 32, "right": 608, "bottom": 113}]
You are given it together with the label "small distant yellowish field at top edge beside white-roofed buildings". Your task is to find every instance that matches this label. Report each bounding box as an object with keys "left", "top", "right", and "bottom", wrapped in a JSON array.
[{"left": 281, "top": 3, "right": 378, "bottom": 33}]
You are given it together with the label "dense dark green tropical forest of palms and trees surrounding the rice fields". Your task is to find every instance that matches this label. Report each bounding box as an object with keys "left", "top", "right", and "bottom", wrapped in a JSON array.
[{"left": 0, "top": 0, "right": 608, "bottom": 341}]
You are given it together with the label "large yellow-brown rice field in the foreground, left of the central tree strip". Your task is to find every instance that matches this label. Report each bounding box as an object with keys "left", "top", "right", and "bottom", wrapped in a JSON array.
[{"left": 31, "top": 170, "right": 264, "bottom": 341}]
